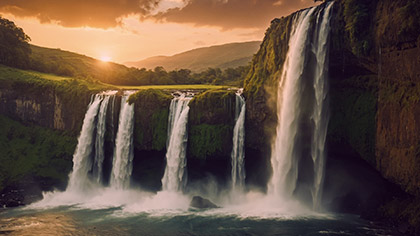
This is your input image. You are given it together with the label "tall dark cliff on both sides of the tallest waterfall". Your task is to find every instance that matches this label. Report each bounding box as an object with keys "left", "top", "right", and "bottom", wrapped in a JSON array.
[{"left": 244, "top": 0, "right": 420, "bottom": 214}]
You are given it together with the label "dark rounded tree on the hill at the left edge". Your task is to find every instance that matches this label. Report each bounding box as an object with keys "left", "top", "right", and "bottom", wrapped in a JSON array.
[{"left": 0, "top": 16, "right": 31, "bottom": 68}]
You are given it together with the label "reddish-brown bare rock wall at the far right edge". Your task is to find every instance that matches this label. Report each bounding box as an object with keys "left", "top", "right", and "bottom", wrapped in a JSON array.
[{"left": 375, "top": 1, "right": 420, "bottom": 196}]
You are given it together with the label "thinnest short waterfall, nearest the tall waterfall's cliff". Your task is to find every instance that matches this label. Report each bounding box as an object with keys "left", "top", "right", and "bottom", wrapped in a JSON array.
[{"left": 231, "top": 90, "right": 245, "bottom": 191}]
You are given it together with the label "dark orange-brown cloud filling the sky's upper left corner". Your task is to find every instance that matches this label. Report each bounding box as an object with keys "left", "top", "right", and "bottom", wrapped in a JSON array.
[{"left": 0, "top": 0, "right": 160, "bottom": 28}]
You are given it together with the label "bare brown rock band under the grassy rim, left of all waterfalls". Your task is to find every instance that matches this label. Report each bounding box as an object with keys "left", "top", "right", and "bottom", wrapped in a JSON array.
[{"left": 0, "top": 83, "right": 90, "bottom": 135}]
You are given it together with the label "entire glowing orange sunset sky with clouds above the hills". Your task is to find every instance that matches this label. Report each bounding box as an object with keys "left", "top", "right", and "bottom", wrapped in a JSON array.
[{"left": 0, "top": 0, "right": 313, "bottom": 63}]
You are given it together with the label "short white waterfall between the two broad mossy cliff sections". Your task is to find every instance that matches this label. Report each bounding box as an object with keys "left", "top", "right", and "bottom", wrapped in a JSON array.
[{"left": 162, "top": 94, "right": 192, "bottom": 192}]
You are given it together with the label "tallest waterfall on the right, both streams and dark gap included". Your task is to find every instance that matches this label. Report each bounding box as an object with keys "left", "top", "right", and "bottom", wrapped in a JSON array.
[{"left": 269, "top": 2, "right": 333, "bottom": 208}]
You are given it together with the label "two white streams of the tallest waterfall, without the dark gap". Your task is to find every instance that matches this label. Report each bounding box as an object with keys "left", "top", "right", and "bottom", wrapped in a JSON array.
[{"left": 269, "top": 3, "right": 333, "bottom": 207}]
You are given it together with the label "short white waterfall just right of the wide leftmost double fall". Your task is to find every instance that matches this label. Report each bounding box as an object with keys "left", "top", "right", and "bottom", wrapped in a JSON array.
[{"left": 111, "top": 91, "right": 134, "bottom": 189}]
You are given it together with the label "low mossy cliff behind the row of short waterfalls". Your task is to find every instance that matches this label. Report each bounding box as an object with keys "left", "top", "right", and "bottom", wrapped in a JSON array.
[{"left": 0, "top": 81, "right": 235, "bottom": 197}]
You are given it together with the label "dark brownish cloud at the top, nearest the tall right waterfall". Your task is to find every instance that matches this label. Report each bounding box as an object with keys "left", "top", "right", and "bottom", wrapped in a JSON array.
[{"left": 153, "top": 0, "right": 314, "bottom": 29}]
